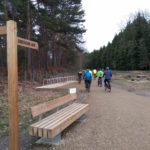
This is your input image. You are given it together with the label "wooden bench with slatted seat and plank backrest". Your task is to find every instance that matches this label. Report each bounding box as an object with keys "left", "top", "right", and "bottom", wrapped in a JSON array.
[{"left": 29, "top": 94, "right": 89, "bottom": 144}]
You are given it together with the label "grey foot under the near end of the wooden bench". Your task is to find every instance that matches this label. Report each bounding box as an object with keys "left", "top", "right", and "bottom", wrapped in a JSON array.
[{"left": 36, "top": 134, "right": 61, "bottom": 145}]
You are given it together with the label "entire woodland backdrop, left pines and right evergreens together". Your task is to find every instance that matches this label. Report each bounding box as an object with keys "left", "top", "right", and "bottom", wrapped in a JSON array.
[{"left": 0, "top": 0, "right": 150, "bottom": 80}]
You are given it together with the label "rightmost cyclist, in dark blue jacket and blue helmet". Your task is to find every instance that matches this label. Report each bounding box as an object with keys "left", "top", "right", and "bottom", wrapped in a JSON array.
[{"left": 104, "top": 67, "right": 112, "bottom": 92}]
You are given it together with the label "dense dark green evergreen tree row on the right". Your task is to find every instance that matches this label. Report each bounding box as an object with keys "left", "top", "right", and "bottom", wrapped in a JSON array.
[{"left": 85, "top": 13, "right": 150, "bottom": 70}]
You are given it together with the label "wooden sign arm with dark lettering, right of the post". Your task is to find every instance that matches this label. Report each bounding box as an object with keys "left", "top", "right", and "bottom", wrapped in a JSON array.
[{"left": 17, "top": 37, "right": 39, "bottom": 50}]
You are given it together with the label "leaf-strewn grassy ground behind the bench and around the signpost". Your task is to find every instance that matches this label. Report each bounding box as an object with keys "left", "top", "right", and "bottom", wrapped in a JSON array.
[{"left": 0, "top": 82, "right": 68, "bottom": 138}]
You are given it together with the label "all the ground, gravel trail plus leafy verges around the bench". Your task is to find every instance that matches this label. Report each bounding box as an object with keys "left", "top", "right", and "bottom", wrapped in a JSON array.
[{"left": 0, "top": 71, "right": 150, "bottom": 150}]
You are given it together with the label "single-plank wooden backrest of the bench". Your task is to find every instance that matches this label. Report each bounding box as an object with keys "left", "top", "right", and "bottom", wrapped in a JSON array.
[{"left": 30, "top": 94, "right": 77, "bottom": 117}]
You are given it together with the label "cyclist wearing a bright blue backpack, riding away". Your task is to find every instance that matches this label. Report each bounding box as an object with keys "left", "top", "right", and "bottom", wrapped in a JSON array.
[{"left": 84, "top": 69, "right": 92, "bottom": 92}]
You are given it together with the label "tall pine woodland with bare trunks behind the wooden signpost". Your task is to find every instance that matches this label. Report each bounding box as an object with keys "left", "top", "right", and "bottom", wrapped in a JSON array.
[{"left": 0, "top": 0, "right": 86, "bottom": 80}]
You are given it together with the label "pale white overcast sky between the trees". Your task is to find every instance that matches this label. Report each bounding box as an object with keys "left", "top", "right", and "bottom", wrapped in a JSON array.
[{"left": 82, "top": 0, "right": 150, "bottom": 52}]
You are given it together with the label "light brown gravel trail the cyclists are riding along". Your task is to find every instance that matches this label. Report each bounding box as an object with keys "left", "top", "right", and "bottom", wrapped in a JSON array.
[{"left": 33, "top": 80, "right": 150, "bottom": 150}]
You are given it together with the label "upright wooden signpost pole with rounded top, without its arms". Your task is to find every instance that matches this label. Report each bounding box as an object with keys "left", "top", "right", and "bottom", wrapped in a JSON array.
[{"left": 7, "top": 20, "right": 20, "bottom": 150}]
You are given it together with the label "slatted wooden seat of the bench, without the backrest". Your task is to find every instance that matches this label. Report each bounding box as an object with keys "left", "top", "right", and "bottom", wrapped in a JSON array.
[{"left": 29, "top": 103, "right": 89, "bottom": 138}]
